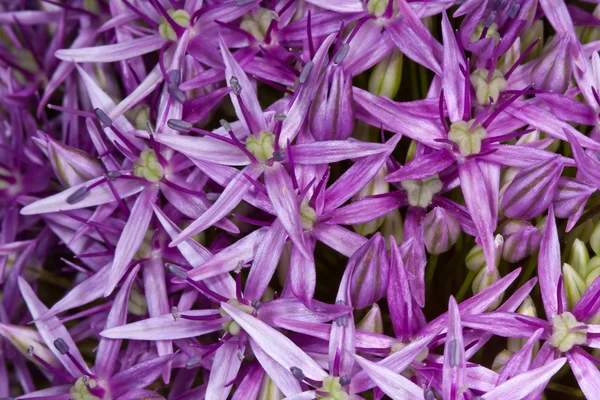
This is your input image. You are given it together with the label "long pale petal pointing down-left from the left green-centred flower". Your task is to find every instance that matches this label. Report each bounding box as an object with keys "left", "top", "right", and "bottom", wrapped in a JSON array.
[{"left": 104, "top": 187, "right": 158, "bottom": 297}]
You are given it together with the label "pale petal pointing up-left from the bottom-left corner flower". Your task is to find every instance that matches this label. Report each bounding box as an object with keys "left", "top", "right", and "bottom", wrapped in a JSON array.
[{"left": 19, "top": 277, "right": 91, "bottom": 376}]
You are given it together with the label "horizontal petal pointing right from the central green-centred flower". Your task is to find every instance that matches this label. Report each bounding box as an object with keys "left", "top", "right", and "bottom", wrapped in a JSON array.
[{"left": 292, "top": 140, "right": 390, "bottom": 164}]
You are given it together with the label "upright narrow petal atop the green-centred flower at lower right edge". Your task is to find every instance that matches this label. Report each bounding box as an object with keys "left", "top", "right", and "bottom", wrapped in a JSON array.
[{"left": 538, "top": 206, "right": 562, "bottom": 319}]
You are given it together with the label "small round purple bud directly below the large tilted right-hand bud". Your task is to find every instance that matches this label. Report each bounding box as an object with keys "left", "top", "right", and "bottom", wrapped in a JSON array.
[{"left": 502, "top": 220, "right": 542, "bottom": 263}]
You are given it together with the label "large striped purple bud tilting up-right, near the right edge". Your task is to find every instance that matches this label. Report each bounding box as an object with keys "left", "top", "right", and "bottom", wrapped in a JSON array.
[{"left": 502, "top": 157, "right": 563, "bottom": 219}]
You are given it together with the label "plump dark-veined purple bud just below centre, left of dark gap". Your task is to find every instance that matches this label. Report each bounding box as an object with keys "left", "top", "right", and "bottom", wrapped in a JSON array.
[{"left": 347, "top": 233, "right": 389, "bottom": 309}]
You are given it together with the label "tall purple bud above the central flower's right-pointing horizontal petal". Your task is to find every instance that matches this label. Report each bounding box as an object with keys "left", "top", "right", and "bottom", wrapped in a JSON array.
[{"left": 310, "top": 68, "right": 355, "bottom": 140}]
